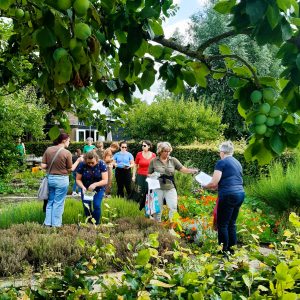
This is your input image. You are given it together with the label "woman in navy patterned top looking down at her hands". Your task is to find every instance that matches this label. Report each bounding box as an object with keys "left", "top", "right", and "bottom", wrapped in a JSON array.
[{"left": 76, "top": 151, "right": 108, "bottom": 224}]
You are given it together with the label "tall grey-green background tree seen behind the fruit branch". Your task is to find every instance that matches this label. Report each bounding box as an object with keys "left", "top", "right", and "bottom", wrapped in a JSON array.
[{"left": 182, "top": 1, "right": 283, "bottom": 139}]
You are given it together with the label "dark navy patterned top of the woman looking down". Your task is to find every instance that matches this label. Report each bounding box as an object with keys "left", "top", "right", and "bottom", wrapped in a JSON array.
[{"left": 76, "top": 160, "right": 107, "bottom": 192}]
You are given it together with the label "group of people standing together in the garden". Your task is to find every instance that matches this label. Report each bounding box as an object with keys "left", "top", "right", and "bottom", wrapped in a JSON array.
[{"left": 41, "top": 133, "right": 245, "bottom": 255}]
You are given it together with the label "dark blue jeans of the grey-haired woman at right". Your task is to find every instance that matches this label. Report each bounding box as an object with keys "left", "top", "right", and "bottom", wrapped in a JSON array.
[{"left": 217, "top": 192, "right": 245, "bottom": 251}]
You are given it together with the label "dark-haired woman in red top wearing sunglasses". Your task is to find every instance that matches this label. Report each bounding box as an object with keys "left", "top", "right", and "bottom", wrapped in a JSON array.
[{"left": 132, "top": 140, "right": 156, "bottom": 209}]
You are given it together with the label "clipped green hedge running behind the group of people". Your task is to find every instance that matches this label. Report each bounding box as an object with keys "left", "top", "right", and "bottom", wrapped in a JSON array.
[{"left": 26, "top": 142, "right": 293, "bottom": 180}]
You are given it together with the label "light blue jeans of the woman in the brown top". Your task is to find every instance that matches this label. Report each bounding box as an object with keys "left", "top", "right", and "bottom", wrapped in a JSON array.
[{"left": 44, "top": 174, "right": 69, "bottom": 227}]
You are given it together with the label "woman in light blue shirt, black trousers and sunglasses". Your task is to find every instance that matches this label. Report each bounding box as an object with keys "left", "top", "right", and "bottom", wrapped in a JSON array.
[{"left": 113, "top": 142, "right": 134, "bottom": 198}]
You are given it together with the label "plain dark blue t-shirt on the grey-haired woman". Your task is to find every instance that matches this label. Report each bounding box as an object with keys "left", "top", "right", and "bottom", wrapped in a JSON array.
[{"left": 215, "top": 156, "right": 244, "bottom": 195}]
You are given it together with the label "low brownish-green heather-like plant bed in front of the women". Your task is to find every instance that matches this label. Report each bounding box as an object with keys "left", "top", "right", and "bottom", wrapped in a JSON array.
[{"left": 0, "top": 217, "right": 174, "bottom": 276}]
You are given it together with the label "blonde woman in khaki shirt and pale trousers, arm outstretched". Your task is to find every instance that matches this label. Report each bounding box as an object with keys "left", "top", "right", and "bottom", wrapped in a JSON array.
[{"left": 148, "top": 142, "right": 198, "bottom": 222}]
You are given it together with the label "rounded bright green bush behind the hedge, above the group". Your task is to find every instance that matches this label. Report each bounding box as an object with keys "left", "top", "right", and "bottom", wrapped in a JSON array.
[{"left": 119, "top": 99, "right": 224, "bottom": 145}]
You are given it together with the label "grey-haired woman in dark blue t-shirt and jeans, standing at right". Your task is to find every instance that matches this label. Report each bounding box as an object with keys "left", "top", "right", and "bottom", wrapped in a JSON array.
[{"left": 204, "top": 141, "right": 245, "bottom": 252}]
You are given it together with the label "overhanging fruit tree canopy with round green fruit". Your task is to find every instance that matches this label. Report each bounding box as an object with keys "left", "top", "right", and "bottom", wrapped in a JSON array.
[{"left": 0, "top": 0, "right": 300, "bottom": 163}]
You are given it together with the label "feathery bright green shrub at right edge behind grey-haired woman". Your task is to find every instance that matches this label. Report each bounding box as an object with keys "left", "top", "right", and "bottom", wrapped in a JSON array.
[{"left": 247, "top": 152, "right": 300, "bottom": 212}]
